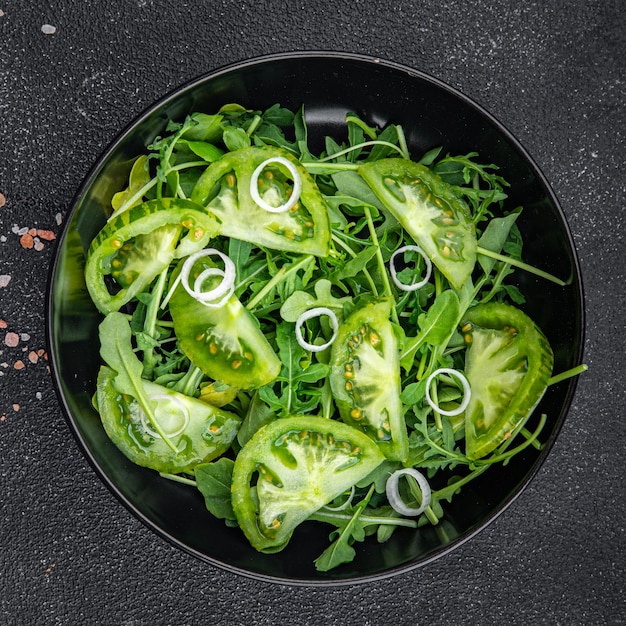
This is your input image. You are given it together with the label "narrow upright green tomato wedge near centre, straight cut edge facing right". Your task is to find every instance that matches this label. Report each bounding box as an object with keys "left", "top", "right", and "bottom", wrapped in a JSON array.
[{"left": 330, "top": 300, "right": 409, "bottom": 461}]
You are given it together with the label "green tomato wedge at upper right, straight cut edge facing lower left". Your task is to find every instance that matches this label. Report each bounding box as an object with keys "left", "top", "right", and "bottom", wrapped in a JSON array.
[{"left": 359, "top": 158, "right": 477, "bottom": 289}]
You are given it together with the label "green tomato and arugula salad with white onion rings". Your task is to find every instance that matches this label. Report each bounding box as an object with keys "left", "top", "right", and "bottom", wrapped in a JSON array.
[{"left": 85, "top": 104, "right": 578, "bottom": 571}]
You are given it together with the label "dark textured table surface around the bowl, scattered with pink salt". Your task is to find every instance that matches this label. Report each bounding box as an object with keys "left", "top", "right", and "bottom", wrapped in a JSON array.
[{"left": 0, "top": 0, "right": 626, "bottom": 626}]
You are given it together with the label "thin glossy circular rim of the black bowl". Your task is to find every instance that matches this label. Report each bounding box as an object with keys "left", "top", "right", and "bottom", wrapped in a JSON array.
[{"left": 45, "top": 50, "right": 586, "bottom": 588}]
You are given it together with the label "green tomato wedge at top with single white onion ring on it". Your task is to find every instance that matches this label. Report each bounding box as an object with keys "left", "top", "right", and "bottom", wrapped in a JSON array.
[{"left": 191, "top": 147, "right": 331, "bottom": 256}]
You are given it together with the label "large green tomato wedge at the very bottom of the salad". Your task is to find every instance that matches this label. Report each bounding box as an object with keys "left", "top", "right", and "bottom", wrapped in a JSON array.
[{"left": 232, "top": 415, "right": 385, "bottom": 552}]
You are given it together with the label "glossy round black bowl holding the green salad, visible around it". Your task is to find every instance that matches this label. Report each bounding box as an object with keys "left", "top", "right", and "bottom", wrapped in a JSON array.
[{"left": 47, "top": 52, "right": 584, "bottom": 585}]
